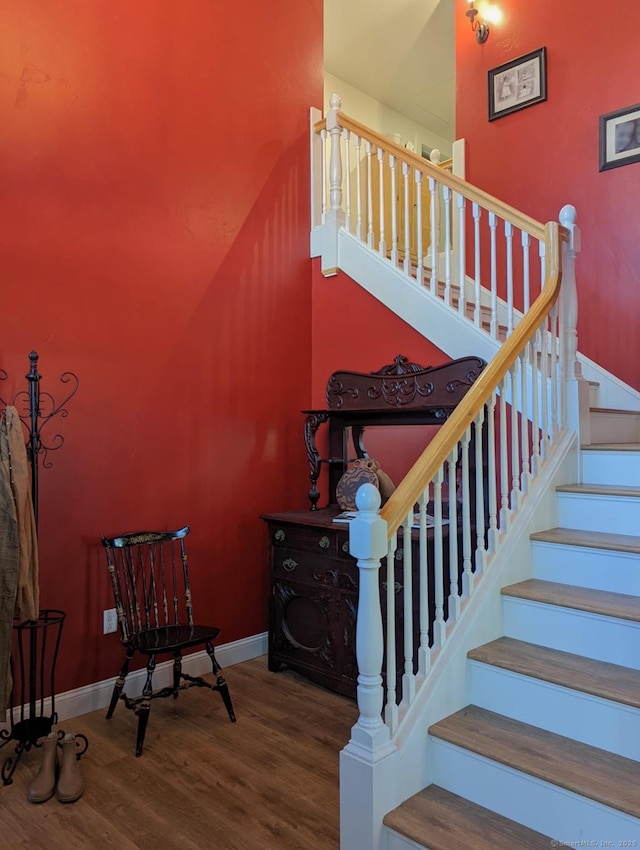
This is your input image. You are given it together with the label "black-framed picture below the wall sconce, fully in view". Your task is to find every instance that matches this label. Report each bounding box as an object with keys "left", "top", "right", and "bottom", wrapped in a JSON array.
[{"left": 489, "top": 47, "right": 547, "bottom": 121}]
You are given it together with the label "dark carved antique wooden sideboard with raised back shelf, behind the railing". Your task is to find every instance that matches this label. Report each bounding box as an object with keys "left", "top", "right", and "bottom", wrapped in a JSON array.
[{"left": 262, "top": 355, "right": 485, "bottom": 697}]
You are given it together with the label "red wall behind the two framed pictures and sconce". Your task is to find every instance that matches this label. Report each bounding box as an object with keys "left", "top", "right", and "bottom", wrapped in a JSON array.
[{"left": 456, "top": 0, "right": 640, "bottom": 389}]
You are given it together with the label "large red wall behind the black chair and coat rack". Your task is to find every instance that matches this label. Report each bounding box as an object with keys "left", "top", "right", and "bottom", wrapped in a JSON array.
[{"left": 0, "top": 0, "right": 323, "bottom": 691}]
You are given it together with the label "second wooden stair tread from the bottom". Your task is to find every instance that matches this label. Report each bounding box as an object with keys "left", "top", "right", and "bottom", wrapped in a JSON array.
[{"left": 429, "top": 705, "right": 640, "bottom": 817}]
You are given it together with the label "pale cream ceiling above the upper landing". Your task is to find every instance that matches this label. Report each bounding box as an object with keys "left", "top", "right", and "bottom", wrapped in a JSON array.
[{"left": 324, "top": 0, "right": 455, "bottom": 140}]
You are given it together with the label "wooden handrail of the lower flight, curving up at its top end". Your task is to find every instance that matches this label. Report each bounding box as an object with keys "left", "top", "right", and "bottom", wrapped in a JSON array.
[{"left": 380, "top": 220, "right": 569, "bottom": 540}]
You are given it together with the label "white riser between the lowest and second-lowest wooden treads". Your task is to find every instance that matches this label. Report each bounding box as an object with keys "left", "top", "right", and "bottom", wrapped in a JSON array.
[{"left": 428, "top": 737, "right": 640, "bottom": 847}]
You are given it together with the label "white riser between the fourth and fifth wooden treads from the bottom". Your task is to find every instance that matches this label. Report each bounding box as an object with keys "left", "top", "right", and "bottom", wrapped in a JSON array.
[{"left": 531, "top": 540, "right": 640, "bottom": 596}]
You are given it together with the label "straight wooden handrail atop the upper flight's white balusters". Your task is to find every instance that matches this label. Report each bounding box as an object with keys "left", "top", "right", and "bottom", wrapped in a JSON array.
[{"left": 313, "top": 112, "right": 544, "bottom": 241}]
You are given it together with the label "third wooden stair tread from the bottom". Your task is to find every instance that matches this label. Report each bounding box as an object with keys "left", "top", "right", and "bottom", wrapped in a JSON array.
[{"left": 467, "top": 637, "right": 640, "bottom": 709}]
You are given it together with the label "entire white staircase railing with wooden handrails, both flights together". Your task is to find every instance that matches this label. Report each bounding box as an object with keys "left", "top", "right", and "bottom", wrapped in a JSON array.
[{"left": 312, "top": 96, "right": 588, "bottom": 850}]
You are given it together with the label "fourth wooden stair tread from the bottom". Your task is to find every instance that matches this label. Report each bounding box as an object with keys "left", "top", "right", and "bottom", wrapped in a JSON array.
[{"left": 500, "top": 578, "right": 640, "bottom": 623}]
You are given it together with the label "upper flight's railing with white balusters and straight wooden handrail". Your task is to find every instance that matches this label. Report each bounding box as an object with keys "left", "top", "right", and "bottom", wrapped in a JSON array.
[{"left": 311, "top": 95, "right": 546, "bottom": 340}]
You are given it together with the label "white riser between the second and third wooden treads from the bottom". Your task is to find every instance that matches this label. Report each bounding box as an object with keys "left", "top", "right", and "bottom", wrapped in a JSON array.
[{"left": 468, "top": 660, "right": 640, "bottom": 761}]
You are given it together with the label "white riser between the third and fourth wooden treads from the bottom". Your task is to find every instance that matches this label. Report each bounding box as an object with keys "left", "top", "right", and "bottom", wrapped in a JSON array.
[{"left": 502, "top": 596, "right": 640, "bottom": 670}]
